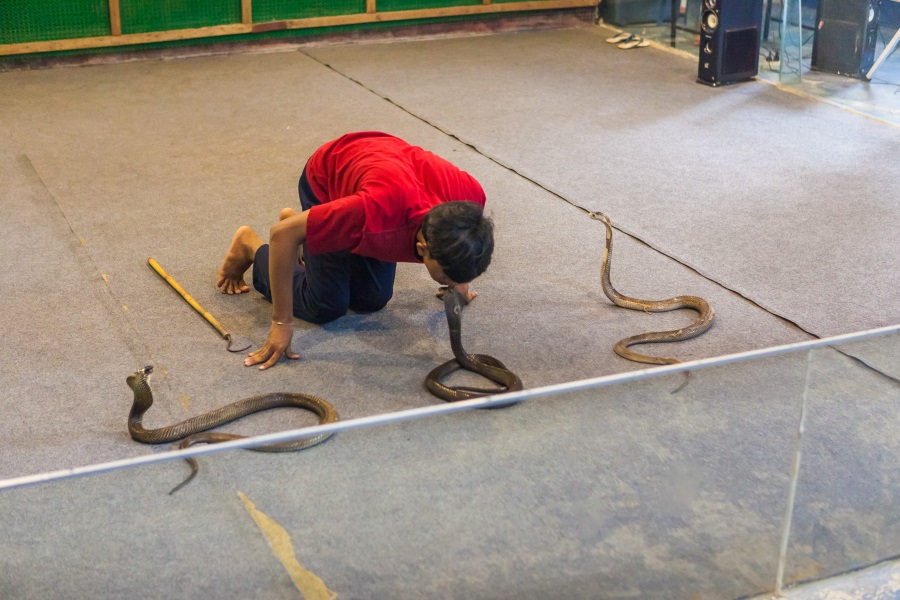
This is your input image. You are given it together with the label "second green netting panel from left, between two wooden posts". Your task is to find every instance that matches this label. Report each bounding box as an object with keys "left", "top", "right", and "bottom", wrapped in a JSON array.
[{"left": 119, "top": 0, "right": 241, "bottom": 33}]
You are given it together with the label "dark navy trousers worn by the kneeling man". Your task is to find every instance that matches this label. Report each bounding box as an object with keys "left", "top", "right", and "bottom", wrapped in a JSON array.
[{"left": 253, "top": 169, "right": 397, "bottom": 323}]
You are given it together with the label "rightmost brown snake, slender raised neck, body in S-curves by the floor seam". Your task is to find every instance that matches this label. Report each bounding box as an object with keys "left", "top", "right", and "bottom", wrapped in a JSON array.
[{"left": 590, "top": 212, "right": 715, "bottom": 368}]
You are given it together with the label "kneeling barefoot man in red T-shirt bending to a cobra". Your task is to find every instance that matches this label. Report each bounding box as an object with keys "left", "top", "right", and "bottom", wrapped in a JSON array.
[{"left": 217, "top": 132, "right": 494, "bottom": 369}]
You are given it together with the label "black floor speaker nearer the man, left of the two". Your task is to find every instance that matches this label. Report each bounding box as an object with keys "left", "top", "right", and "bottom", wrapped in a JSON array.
[{"left": 697, "top": 0, "right": 762, "bottom": 86}]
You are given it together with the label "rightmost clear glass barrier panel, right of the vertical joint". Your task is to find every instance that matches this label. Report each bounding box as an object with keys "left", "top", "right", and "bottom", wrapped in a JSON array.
[{"left": 785, "top": 334, "right": 900, "bottom": 583}]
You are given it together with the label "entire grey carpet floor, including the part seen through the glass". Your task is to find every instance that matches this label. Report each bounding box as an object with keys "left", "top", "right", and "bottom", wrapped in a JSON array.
[{"left": 0, "top": 27, "right": 900, "bottom": 598}]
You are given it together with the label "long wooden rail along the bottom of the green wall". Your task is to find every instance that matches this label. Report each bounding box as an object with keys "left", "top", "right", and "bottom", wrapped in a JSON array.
[{"left": 0, "top": 0, "right": 597, "bottom": 56}]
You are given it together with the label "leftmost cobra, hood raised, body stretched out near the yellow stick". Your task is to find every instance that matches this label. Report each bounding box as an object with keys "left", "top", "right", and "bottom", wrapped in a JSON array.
[{"left": 125, "top": 366, "right": 338, "bottom": 494}]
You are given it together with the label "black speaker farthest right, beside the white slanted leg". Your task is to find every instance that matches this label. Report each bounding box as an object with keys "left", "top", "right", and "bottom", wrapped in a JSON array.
[{"left": 812, "top": 0, "right": 881, "bottom": 79}]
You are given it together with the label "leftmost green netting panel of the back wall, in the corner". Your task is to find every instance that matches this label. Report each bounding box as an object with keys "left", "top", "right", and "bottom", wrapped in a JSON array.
[{"left": 0, "top": 0, "right": 109, "bottom": 44}]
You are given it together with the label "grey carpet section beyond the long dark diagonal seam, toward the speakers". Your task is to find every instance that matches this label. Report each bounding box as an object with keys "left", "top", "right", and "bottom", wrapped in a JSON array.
[{"left": 302, "top": 29, "right": 900, "bottom": 336}]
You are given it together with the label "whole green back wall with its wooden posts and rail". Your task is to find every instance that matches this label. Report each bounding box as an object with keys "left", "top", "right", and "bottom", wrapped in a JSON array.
[{"left": 0, "top": 0, "right": 596, "bottom": 60}]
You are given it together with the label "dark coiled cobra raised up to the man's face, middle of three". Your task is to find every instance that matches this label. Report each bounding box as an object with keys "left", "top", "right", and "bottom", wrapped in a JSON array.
[{"left": 425, "top": 288, "right": 523, "bottom": 408}]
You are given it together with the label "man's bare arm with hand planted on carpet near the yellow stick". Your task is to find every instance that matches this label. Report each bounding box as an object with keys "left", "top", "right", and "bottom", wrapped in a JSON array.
[{"left": 244, "top": 210, "right": 309, "bottom": 369}]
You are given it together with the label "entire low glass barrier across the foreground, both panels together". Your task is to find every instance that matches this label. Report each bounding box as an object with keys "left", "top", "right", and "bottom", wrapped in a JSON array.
[{"left": 0, "top": 334, "right": 900, "bottom": 598}]
